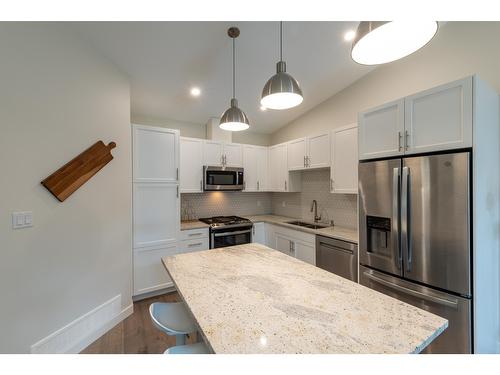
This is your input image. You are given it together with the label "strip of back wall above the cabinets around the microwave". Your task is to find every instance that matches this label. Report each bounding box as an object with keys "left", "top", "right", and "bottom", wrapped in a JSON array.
[{"left": 132, "top": 114, "right": 271, "bottom": 146}]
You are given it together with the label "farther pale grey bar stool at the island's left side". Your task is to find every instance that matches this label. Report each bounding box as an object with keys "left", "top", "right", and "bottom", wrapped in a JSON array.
[{"left": 149, "top": 302, "right": 197, "bottom": 350}]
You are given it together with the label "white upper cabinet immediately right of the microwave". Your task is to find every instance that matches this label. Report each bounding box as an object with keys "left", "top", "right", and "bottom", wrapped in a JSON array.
[{"left": 243, "top": 145, "right": 268, "bottom": 191}]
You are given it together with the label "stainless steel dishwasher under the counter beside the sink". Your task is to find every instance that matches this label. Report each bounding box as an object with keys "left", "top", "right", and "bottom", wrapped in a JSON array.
[{"left": 316, "top": 236, "right": 358, "bottom": 282}]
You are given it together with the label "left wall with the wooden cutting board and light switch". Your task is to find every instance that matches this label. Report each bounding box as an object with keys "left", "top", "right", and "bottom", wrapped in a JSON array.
[{"left": 0, "top": 23, "right": 132, "bottom": 353}]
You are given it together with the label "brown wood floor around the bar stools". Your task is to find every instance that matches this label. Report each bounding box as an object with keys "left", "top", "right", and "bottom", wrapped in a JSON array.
[{"left": 81, "top": 293, "right": 194, "bottom": 354}]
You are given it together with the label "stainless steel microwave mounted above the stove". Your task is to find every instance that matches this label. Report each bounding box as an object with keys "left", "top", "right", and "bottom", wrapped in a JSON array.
[{"left": 203, "top": 165, "right": 244, "bottom": 191}]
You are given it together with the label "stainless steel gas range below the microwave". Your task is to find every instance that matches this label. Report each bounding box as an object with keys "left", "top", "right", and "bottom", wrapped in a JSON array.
[{"left": 199, "top": 216, "right": 253, "bottom": 249}]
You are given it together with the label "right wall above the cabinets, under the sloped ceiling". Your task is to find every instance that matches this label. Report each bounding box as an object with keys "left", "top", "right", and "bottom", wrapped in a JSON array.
[{"left": 271, "top": 22, "right": 500, "bottom": 144}]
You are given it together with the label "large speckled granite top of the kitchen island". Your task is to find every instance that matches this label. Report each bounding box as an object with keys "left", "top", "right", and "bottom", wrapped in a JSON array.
[{"left": 163, "top": 244, "right": 448, "bottom": 353}]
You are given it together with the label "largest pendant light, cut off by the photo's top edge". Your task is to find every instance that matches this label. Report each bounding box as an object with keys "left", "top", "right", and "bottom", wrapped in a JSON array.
[{"left": 351, "top": 21, "right": 438, "bottom": 65}]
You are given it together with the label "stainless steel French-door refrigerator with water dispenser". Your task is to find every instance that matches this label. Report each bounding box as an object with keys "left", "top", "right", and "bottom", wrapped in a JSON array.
[{"left": 359, "top": 152, "right": 472, "bottom": 353}]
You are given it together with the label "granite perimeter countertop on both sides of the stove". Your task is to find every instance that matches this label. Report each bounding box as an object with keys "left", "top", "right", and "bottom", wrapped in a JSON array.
[{"left": 181, "top": 215, "right": 358, "bottom": 244}]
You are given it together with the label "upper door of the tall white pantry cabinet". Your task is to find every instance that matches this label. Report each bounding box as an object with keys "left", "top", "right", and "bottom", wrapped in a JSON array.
[{"left": 132, "top": 125, "right": 179, "bottom": 182}]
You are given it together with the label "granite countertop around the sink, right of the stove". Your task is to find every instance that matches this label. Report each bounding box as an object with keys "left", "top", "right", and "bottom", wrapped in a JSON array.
[{"left": 246, "top": 215, "right": 358, "bottom": 244}]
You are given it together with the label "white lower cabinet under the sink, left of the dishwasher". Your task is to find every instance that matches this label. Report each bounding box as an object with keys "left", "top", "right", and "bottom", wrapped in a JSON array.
[{"left": 265, "top": 224, "right": 316, "bottom": 265}]
